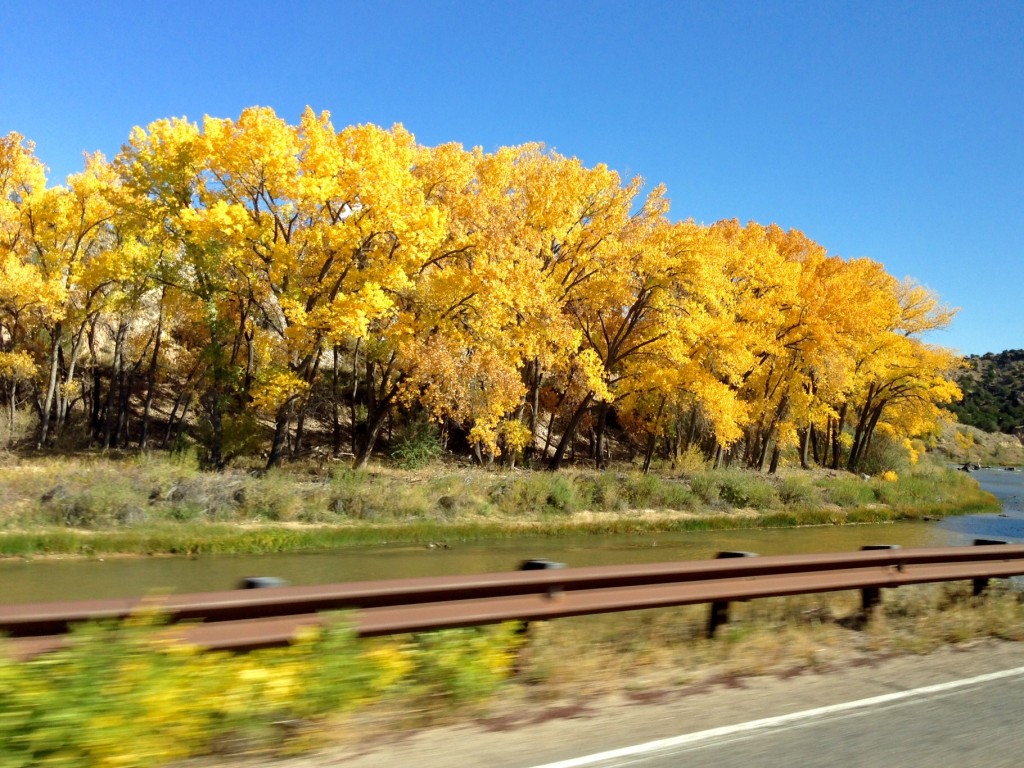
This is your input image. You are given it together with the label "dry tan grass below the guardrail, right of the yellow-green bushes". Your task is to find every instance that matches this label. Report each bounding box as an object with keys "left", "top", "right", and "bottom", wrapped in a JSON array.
[{"left": 509, "top": 583, "right": 1024, "bottom": 700}]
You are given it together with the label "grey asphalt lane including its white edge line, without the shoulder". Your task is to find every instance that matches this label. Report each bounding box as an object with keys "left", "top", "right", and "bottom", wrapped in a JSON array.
[{"left": 544, "top": 668, "right": 1024, "bottom": 768}]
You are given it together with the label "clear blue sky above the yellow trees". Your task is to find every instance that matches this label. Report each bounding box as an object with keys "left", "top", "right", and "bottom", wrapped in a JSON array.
[{"left": 0, "top": 0, "right": 1024, "bottom": 353}]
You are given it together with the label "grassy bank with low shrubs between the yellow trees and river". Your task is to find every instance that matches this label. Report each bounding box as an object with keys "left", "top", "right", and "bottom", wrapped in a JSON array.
[{"left": 0, "top": 455, "right": 997, "bottom": 557}]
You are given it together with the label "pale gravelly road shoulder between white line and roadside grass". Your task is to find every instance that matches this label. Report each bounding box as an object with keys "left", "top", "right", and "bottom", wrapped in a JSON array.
[{"left": 189, "top": 640, "right": 1024, "bottom": 768}]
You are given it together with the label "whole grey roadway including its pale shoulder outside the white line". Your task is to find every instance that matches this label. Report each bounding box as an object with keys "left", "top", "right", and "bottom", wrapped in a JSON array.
[{"left": 214, "top": 641, "right": 1024, "bottom": 768}]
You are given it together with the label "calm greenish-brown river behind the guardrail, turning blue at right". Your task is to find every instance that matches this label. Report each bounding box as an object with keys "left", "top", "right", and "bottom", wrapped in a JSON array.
[{"left": 0, "top": 470, "right": 1024, "bottom": 603}]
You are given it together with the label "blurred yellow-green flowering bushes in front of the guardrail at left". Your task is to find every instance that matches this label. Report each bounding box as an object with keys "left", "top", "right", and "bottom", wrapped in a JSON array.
[{"left": 0, "top": 618, "right": 520, "bottom": 768}]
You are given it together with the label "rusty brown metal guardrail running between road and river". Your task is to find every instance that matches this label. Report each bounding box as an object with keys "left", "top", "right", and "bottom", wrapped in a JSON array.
[{"left": 0, "top": 540, "right": 1024, "bottom": 656}]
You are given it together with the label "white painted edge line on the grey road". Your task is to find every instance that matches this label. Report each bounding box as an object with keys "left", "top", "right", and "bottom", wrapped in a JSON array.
[{"left": 535, "top": 667, "right": 1024, "bottom": 768}]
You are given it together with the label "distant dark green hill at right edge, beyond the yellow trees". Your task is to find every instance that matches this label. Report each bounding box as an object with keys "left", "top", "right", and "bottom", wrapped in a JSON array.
[{"left": 949, "top": 349, "right": 1024, "bottom": 434}]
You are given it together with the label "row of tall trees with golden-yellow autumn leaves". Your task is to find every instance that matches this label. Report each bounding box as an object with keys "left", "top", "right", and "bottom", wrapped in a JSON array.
[{"left": 0, "top": 108, "right": 958, "bottom": 469}]
